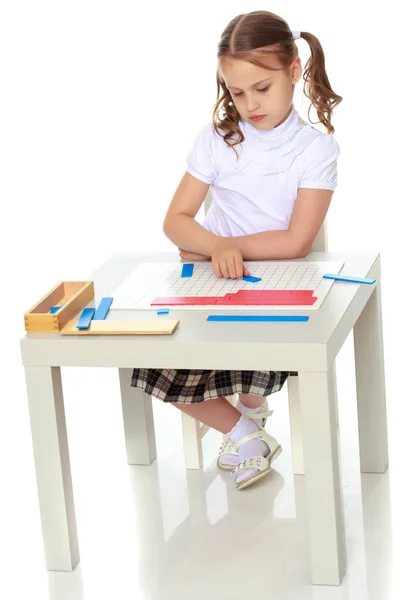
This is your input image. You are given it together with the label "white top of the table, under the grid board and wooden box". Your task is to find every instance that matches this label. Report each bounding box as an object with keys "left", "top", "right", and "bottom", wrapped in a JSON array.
[{"left": 21, "top": 252, "right": 380, "bottom": 371}]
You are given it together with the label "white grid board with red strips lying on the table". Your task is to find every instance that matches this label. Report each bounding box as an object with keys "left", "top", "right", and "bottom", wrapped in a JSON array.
[{"left": 112, "top": 260, "right": 343, "bottom": 310}]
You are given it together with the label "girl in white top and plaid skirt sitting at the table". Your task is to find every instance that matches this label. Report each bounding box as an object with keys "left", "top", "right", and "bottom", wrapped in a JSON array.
[{"left": 132, "top": 11, "right": 342, "bottom": 489}]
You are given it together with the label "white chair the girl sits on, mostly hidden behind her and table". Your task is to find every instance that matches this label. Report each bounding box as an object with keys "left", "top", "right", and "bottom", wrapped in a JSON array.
[{"left": 182, "top": 190, "right": 332, "bottom": 475}]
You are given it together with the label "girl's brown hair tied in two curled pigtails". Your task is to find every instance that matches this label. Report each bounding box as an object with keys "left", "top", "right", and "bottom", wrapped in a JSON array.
[{"left": 213, "top": 10, "right": 343, "bottom": 154}]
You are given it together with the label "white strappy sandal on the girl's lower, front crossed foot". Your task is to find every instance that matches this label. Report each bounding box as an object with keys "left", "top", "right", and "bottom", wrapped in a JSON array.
[{"left": 231, "top": 428, "right": 282, "bottom": 490}]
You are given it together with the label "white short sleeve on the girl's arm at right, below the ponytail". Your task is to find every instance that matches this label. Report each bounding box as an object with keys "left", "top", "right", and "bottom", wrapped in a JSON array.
[{"left": 299, "top": 133, "right": 340, "bottom": 191}]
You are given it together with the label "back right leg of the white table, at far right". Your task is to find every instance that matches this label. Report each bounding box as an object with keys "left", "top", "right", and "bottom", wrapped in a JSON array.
[{"left": 353, "top": 280, "right": 389, "bottom": 473}]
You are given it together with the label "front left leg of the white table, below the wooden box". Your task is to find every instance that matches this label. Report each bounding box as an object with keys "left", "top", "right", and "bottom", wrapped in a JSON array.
[{"left": 25, "top": 366, "right": 79, "bottom": 571}]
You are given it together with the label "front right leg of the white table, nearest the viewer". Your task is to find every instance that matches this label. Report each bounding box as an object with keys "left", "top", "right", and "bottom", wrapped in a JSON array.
[{"left": 298, "top": 368, "right": 347, "bottom": 585}]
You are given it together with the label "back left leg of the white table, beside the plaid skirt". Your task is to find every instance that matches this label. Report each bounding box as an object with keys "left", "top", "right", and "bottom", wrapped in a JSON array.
[{"left": 118, "top": 369, "right": 157, "bottom": 465}]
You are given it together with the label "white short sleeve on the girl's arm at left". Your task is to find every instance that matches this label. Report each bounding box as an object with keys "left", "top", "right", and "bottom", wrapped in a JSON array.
[{"left": 186, "top": 123, "right": 217, "bottom": 184}]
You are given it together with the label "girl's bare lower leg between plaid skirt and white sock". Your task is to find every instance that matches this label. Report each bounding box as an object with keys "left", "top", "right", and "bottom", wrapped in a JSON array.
[{"left": 171, "top": 398, "right": 241, "bottom": 434}]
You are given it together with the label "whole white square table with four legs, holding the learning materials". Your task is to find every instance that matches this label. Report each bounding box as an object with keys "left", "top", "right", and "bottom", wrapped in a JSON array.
[{"left": 21, "top": 252, "right": 388, "bottom": 585}]
